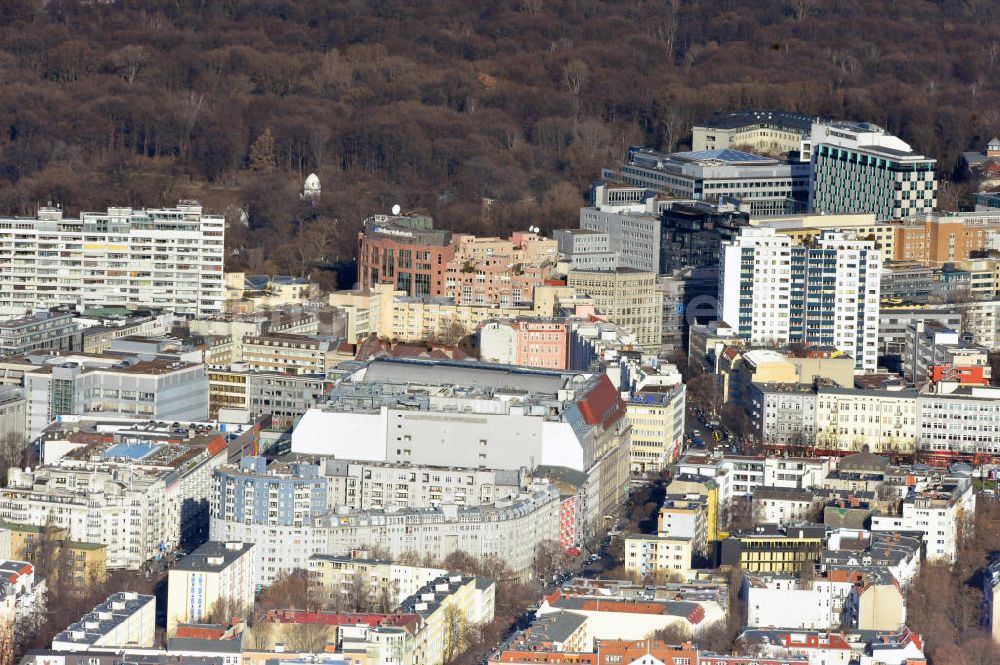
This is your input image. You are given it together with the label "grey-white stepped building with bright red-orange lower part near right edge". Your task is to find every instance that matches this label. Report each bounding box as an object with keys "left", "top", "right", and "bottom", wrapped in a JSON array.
[{"left": 903, "top": 321, "right": 990, "bottom": 389}]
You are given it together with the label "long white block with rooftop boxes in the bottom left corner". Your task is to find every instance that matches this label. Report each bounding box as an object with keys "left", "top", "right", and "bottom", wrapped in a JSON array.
[{"left": 52, "top": 591, "right": 156, "bottom": 651}]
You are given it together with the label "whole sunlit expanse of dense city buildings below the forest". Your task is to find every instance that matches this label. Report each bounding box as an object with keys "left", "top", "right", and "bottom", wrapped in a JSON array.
[{"left": 0, "top": 110, "right": 1000, "bottom": 665}]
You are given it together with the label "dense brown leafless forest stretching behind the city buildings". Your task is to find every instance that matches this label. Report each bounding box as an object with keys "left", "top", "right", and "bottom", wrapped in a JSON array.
[{"left": 0, "top": 0, "right": 1000, "bottom": 282}]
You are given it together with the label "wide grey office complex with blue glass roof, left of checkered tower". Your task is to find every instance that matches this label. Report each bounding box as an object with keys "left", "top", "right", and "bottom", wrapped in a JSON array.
[{"left": 601, "top": 146, "right": 809, "bottom": 216}]
